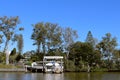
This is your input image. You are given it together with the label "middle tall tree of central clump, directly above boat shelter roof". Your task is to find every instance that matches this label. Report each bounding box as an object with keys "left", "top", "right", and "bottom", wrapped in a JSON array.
[{"left": 45, "top": 23, "right": 62, "bottom": 50}]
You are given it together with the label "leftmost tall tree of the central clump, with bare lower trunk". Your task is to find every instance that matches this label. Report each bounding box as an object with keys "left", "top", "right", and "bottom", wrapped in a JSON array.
[{"left": 31, "top": 22, "right": 47, "bottom": 53}]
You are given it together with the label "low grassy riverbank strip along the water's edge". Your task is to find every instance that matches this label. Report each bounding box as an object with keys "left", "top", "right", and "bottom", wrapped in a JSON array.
[{"left": 0, "top": 64, "right": 120, "bottom": 72}]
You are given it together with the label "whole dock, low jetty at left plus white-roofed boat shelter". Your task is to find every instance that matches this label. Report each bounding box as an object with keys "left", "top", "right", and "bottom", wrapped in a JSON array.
[{"left": 25, "top": 56, "right": 64, "bottom": 73}]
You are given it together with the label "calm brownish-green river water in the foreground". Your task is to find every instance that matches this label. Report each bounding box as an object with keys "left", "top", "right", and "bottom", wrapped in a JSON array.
[{"left": 0, "top": 72, "right": 120, "bottom": 80}]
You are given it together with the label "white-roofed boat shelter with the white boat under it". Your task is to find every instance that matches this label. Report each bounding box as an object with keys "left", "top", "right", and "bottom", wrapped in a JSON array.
[{"left": 43, "top": 56, "right": 63, "bottom": 73}]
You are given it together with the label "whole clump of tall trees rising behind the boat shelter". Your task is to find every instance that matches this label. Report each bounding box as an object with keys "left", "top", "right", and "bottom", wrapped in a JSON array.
[{"left": 31, "top": 22, "right": 78, "bottom": 55}]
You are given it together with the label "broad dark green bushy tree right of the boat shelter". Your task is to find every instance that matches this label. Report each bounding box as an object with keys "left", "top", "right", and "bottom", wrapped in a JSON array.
[{"left": 69, "top": 42, "right": 101, "bottom": 71}]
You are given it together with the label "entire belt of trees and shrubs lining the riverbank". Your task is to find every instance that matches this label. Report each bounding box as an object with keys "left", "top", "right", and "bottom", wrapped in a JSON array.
[{"left": 0, "top": 16, "right": 120, "bottom": 72}]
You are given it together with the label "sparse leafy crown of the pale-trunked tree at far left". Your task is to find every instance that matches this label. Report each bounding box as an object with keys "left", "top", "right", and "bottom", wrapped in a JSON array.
[{"left": 0, "top": 16, "right": 22, "bottom": 52}]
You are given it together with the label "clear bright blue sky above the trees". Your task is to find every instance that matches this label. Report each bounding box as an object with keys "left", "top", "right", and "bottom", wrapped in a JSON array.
[{"left": 0, "top": 0, "right": 120, "bottom": 52}]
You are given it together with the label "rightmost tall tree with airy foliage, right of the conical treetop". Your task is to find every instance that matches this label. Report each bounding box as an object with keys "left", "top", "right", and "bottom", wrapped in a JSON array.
[{"left": 97, "top": 33, "right": 117, "bottom": 59}]
